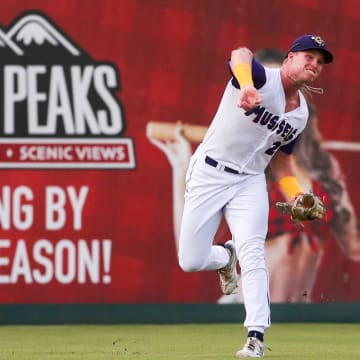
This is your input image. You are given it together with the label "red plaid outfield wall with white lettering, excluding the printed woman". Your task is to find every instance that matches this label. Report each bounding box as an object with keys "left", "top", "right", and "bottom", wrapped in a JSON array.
[{"left": 0, "top": 0, "right": 360, "bottom": 303}]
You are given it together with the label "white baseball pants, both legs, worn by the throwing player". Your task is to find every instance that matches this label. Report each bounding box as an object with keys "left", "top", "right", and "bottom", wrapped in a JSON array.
[{"left": 179, "top": 153, "right": 270, "bottom": 329}]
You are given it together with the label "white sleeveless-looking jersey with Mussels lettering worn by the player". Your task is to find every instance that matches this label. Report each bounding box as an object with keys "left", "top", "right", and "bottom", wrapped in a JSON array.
[{"left": 198, "top": 68, "right": 308, "bottom": 174}]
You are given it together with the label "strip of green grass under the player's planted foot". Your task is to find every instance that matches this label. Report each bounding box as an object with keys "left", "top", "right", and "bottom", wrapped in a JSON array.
[{"left": 0, "top": 323, "right": 360, "bottom": 360}]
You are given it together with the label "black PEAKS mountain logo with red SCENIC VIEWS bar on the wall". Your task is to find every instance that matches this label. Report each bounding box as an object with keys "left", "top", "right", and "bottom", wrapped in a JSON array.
[{"left": 0, "top": 11, "right": 135, "bottom": 169}]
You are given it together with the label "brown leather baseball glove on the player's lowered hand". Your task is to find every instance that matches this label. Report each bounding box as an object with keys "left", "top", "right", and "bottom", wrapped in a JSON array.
[{"left": 276, "top": 192, "right": 326, "bottom": 224}]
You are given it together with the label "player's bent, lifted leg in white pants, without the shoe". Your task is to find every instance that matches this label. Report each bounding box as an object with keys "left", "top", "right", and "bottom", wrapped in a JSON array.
[{"left": 179, "top": 159, "right": 230, "bottom": 271}]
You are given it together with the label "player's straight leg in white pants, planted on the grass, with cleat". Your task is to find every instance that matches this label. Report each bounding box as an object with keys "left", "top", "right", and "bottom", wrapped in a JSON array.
[{"left": 224, "top": 175, "right": 270, "bottom": 358}]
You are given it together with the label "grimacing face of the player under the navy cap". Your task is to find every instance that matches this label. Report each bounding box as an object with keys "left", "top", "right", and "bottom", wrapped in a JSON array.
[{"left": 291, "top": 50, "right": 324, "bottom": 84}]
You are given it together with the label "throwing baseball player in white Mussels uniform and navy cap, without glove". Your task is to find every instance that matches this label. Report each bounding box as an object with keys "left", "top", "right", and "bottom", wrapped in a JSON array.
[{"left": 179, "top": 35, "right": 333, "bottom": 358}]
